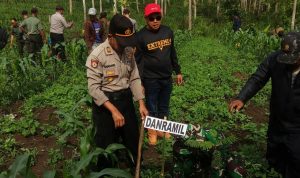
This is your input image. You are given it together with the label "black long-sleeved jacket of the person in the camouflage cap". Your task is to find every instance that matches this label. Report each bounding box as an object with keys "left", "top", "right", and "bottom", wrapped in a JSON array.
[{"left": 237, "top": 51, "right": 300, "bottom": 133}]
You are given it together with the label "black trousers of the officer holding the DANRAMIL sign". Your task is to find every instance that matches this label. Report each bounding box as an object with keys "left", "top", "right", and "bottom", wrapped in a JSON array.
[{"left": 92, "top": 89, "right": 139, "bottom": 169}]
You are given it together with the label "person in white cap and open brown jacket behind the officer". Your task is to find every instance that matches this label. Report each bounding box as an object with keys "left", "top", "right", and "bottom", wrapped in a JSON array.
[{"left": 84, "top": 8, "right": 105, "bottom": 54}]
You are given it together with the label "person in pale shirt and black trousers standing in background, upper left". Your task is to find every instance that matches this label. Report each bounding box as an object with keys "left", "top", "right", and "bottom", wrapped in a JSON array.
[{"left": 50, "top": 6, "right": 73, "bottom": 60}]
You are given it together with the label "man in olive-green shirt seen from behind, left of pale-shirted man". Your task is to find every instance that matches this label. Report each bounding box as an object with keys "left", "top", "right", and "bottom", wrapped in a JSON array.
[{"left": 20, "top": 8, "right": 46, "bottom": 57}]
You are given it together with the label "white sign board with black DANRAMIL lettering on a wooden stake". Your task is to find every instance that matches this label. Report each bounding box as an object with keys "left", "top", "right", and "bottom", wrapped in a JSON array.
[{"left": 144, "top": 116, "right": 188, "bottom": 136}]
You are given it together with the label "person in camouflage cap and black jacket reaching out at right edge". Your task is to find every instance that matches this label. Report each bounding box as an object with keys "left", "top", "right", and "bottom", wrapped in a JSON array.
[{"left": 229, "top": 32, "right": 300, "bottom": 178}]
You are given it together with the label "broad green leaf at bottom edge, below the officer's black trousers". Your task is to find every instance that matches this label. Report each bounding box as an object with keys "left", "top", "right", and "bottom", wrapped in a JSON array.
[{"left": 87, "top": 168, "right": 132, "bottom": 178}]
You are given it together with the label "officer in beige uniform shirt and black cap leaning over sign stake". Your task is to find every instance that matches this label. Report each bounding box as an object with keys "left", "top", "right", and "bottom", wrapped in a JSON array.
[{"left": 86, "top": 14, "right": 148, "bottom": 169}]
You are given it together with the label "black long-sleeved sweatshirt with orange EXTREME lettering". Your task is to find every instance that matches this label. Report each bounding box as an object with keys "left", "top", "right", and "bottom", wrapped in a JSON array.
[{"left": 135, "top": 25, "right": 180, "bottom": 79}]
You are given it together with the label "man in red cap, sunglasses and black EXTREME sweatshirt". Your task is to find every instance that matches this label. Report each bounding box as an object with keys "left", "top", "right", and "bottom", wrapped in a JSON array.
[{"left": 136, "top": 3, "right": 183, "bottom": 145}]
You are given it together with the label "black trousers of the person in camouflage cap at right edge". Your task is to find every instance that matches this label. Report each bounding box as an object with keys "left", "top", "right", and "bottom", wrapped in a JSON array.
[{"left": 267, "top": 132, "right": 300, "bottom": 178}]
